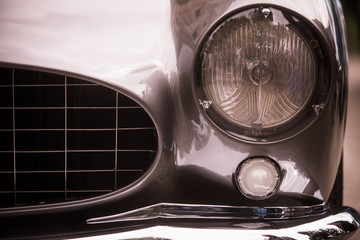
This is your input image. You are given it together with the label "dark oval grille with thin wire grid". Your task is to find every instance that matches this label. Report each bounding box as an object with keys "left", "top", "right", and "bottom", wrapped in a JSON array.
[{"left": 0, "top": 68, "right": 157, "bottom": 207}]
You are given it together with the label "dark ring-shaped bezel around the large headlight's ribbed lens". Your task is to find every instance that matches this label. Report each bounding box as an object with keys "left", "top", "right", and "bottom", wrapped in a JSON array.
[{"left": 194, "top": 5, "right": 334, "bottom": 143}]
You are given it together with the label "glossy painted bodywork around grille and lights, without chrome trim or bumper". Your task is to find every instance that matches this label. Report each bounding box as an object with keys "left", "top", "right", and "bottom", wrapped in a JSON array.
[{"left": 0, "top": 0, "right": 347, "bottom": 237}]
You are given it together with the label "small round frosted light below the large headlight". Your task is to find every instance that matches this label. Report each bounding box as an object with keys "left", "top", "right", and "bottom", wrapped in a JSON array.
[{"left": 236, "top": 157, "right": 280, "bottom": 199}]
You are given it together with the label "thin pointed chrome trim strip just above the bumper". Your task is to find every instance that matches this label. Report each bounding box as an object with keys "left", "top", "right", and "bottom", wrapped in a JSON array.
[{"left": 87, "top": 203, "right": 328, "bottom": 224}]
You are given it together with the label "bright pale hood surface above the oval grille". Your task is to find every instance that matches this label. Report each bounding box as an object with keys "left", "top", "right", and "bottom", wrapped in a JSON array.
[{"left": 0, "top": 0, "right": 176, "bottom": 82}]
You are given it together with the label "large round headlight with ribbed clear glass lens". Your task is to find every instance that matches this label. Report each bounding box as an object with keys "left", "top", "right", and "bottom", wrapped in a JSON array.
[{"left": 198, "top": 7, "right": 329, "bottom": 140}]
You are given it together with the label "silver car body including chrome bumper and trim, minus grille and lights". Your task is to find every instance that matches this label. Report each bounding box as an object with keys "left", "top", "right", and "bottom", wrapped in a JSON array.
[{"left": 0, "top": 0, "right": 360, "bottom": 239}]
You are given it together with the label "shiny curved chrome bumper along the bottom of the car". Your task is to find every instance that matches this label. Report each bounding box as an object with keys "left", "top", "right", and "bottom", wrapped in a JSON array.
[{"left": 71, "top": 208, "right": 360, "bottom": 240}]
